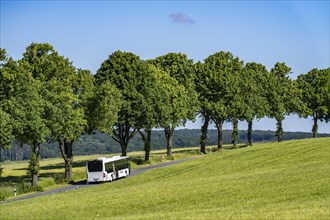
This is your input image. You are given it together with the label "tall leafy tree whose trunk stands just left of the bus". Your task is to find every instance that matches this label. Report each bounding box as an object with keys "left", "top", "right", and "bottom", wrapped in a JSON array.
[{"left": 23, "top": 43, "right": 87, "bottom": 181}]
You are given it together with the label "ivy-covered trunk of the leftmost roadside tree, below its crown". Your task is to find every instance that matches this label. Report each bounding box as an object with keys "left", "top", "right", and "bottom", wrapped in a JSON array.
[{"left": 28, "top": 142, "right": 40, "bottom": 186}]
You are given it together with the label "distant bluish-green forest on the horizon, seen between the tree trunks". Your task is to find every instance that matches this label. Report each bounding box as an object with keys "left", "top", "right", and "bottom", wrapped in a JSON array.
[{"left": 0, "top": 129, "right": 330, "bottom": 161}]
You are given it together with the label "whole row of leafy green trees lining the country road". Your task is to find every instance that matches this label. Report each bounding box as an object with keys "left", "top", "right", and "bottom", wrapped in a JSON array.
[{"left": 0, "top": 43, "right": 330, "bottom": 186}]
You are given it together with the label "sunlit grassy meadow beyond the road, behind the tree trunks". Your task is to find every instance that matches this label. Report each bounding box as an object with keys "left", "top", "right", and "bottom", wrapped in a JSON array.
[{"left": 0, "top": 148, "right": 199, "bottom": 201}]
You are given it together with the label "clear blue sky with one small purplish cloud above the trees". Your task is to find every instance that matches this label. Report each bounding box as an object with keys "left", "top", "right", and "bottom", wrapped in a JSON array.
[{"left": 0, "top": 0, "right": 330, "bottom": 133}]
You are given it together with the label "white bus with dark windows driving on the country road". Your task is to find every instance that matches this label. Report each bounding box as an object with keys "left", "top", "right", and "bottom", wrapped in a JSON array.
[{"left": 86, "top": 156, "right": 131, "bottom": 184}]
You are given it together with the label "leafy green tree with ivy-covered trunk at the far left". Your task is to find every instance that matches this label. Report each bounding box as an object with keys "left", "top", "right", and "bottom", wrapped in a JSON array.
[{"left": 1, "top": 59, "right": 49, "bottom": 186}]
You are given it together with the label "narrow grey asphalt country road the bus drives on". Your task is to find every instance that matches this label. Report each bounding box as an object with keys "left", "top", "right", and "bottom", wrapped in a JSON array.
[{"left": 0, "top": 157, "right": 196, "bottom": 205}]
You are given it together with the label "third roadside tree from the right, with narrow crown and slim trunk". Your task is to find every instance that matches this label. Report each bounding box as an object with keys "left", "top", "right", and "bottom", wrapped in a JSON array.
[{"left": 240, "top": 62, "right": 269, "bottom": 146}]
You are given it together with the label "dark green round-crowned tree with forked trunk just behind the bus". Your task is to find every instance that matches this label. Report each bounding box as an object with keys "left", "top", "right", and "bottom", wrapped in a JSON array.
[{"left": 95, "top": 51, "right": 150, "bottom": 156}]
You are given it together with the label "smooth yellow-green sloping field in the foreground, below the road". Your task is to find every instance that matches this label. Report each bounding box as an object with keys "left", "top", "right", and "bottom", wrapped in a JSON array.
[{"left": 0, "top": 138, "right": 330, "bottom": 219}]
